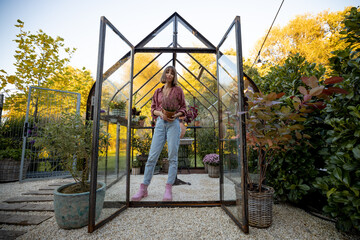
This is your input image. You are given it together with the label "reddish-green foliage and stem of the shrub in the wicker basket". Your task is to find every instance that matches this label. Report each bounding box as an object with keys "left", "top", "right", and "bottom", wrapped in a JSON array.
[{"left": 245, "top": 93, "right": 309, "bottom": 192}]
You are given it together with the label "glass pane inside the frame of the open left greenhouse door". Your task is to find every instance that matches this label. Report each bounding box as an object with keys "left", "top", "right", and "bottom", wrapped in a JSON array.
[{"left": 96, "top": 23, "right": 131, "bottom": 223}]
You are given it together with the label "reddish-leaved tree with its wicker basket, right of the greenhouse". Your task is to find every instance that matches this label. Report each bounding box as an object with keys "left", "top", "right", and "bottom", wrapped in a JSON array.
[{"left": 242, "top": 74, "right": 344, "bottom": 227}]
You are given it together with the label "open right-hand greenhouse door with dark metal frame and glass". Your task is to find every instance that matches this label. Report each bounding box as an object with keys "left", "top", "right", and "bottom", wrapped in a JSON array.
[{"left": 216, "top": 16, "right": 249, "bottom": 233}]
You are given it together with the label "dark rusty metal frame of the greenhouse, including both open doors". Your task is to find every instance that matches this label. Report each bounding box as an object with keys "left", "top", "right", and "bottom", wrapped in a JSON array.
[{"left": 86, "top": 12, "right": 253, "bottom": 233}]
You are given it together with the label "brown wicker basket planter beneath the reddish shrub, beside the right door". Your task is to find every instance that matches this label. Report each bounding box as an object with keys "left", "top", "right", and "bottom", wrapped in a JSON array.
[{"left": 248, "top": 186, "right": 274, "bottom": 228}]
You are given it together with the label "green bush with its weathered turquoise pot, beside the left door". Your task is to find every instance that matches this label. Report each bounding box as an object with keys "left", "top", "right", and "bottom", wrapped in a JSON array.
[{"left": 33, "top": 113, "right": 109, "bottom": 229}]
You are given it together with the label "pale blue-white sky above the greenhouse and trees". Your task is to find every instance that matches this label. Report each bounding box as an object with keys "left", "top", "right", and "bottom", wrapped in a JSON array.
[{"left": 0, "top": 0, "right": 360, "bottom": 88}]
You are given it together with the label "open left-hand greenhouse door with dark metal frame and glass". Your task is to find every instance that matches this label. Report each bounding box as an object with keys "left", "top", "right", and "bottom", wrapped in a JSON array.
[{"left": 88, "top": 17, "right": 134, "bottom": 232}]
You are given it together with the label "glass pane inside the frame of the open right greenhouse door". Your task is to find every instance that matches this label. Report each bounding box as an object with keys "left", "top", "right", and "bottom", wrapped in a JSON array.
[{"left": 218, "top": 25, "right": 243, "bottom": 227}]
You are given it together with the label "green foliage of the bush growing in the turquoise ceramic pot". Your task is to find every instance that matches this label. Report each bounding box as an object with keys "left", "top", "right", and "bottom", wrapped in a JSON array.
[{"left": 32, "top": 113, "right": 110, "bottom": 192}]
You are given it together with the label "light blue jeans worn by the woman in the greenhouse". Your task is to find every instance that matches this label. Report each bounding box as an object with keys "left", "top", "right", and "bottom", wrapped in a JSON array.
[{"left": 143, "top": 117, "right": 181, "bottom": 185}]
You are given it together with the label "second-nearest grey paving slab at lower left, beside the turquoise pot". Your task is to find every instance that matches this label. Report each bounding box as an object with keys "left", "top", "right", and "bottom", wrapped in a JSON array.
[{"left": 0, "top": 214, "right": 52, "bottom": 226}]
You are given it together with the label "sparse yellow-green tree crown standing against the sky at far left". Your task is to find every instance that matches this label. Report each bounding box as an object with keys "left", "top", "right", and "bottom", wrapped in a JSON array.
[{"left": 0, "top": 20, "right": 75, "bottom": 93}]
